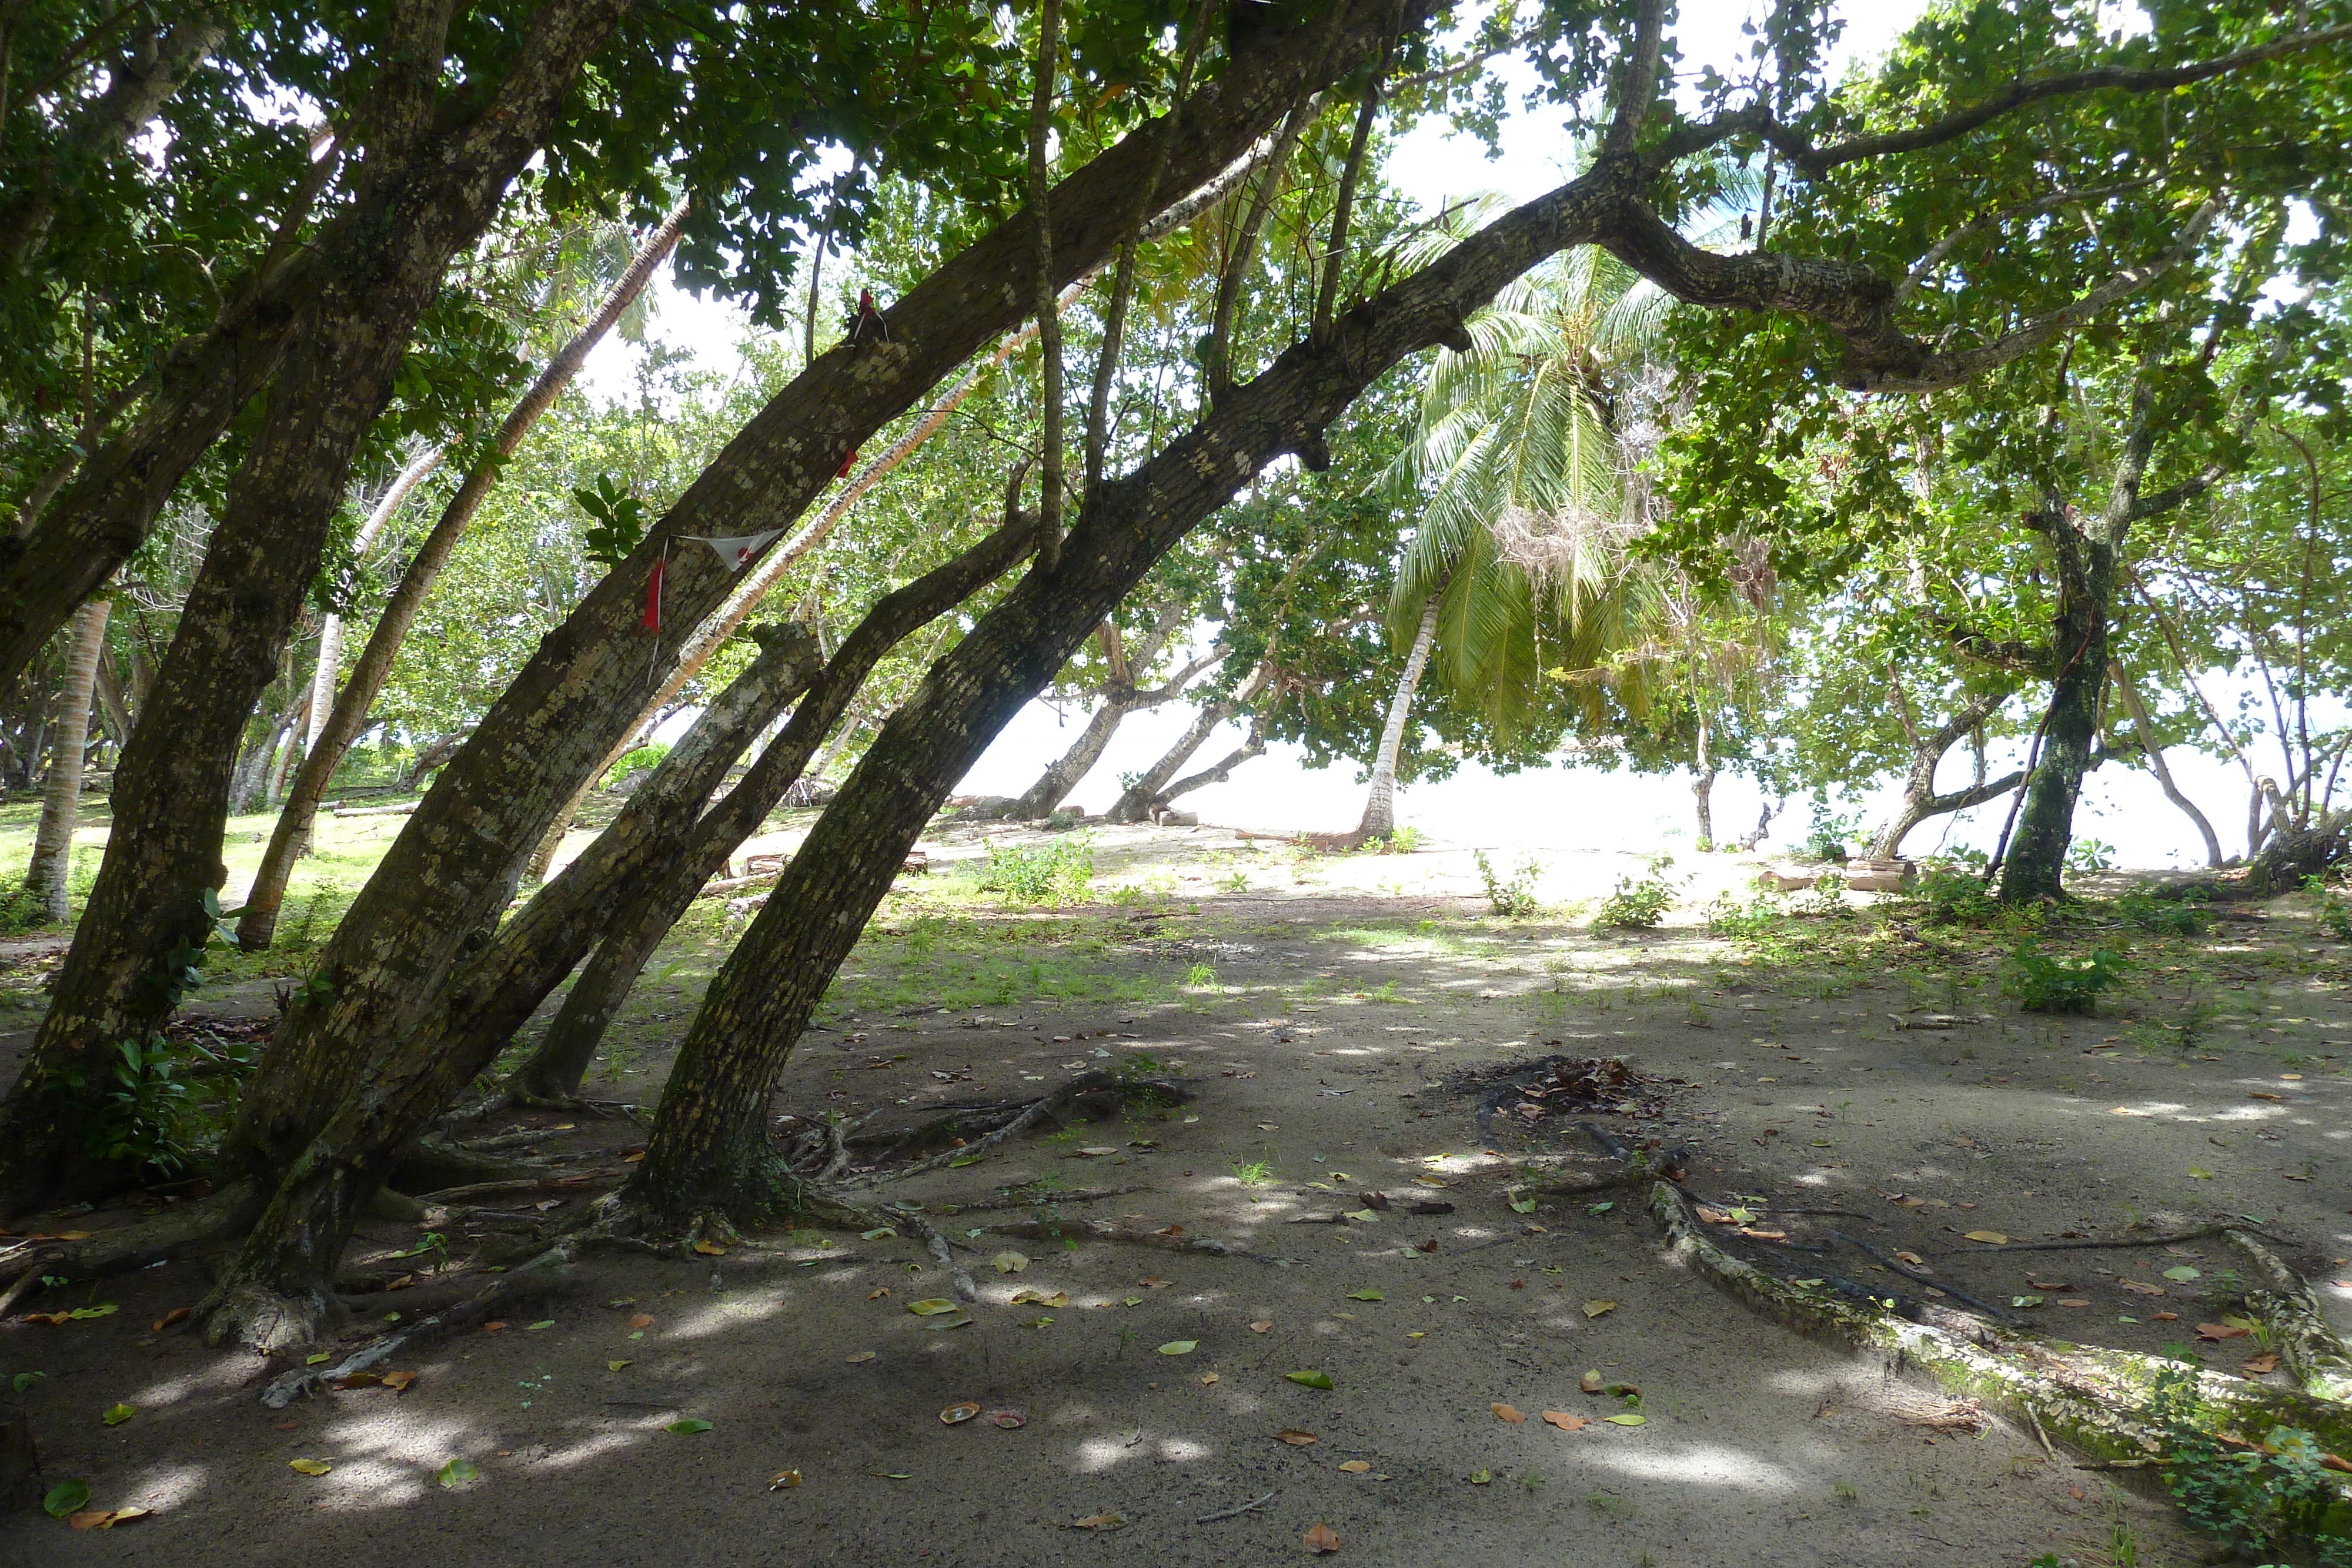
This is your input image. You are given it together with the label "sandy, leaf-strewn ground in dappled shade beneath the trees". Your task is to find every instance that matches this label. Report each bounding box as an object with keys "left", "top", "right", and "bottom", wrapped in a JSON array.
[{"left": 0, "top": 818, "right": 2352, "bottom": 1566}]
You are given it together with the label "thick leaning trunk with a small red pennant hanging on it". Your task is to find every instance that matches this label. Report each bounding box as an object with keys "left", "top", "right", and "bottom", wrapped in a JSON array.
[{"left": 207, "top": 0, "right": 1392, "bottom": 1194}]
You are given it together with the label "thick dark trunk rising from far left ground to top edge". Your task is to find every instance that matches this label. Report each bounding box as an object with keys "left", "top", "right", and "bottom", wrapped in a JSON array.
[{"left": 0, "top": 0, "right": 623, "bottom": 1211}]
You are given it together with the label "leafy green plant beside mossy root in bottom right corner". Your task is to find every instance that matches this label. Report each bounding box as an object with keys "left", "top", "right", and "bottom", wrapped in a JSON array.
[{"left": 2150, "top": 1368, "right": 2352, "bottom": 1568}]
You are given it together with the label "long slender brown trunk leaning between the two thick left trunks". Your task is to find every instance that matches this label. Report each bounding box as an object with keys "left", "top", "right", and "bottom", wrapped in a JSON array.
[{"left": 238, "top": 202, "right": 687, "bottom": 952}]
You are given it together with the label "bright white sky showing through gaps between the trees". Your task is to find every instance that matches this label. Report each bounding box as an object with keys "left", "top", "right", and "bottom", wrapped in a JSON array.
[{"left": 586, "top": 0, "right": 2296, "bottom": 865}]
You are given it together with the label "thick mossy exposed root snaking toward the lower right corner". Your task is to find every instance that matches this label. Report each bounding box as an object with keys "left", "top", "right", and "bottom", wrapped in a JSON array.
[{"left": 1649, "top": 1182, "right": 2352, "bottom": 1497}]
